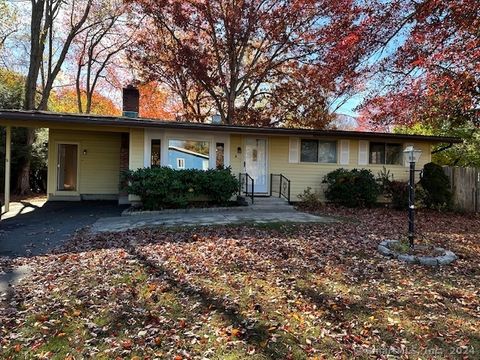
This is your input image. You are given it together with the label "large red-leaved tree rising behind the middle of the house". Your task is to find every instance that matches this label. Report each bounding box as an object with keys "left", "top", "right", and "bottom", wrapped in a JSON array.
[{"left": 126, "top": 0, "right": 375, "bottom": 127}]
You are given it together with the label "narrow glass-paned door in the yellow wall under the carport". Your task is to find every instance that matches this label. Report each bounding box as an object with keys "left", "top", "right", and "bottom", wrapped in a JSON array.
[{"left": 57, "top": 144, "right": 78, "bottom": 192}]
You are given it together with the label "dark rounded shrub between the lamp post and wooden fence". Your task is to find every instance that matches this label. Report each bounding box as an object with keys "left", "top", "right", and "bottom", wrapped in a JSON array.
[{"left": 420, "top": 163, "right": 452, "bottom": 210}]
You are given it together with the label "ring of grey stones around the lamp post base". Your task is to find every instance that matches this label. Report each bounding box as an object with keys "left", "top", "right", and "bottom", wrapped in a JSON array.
[{"left": 378, "top": 240, "right": 457, "bottom": 266}]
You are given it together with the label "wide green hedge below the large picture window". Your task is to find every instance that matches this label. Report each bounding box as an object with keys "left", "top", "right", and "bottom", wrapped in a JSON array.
[{"left": 123, "top": 167, "right": 238, "bottom": 210}]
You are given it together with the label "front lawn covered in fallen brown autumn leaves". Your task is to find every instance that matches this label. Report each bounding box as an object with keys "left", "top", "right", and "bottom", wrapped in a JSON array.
[{"left": 0, "top": 208, "right": 480, "bottom": 359}]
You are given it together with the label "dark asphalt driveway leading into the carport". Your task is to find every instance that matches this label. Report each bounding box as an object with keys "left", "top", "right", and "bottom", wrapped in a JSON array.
[{"left": 0, "top": 201, "right": 125, "bottom": 257}]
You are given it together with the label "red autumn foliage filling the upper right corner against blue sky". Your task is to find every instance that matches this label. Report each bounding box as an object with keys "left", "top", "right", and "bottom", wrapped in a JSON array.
[{"left": 362, "top": 0, "right": 480, "bottom": 128}]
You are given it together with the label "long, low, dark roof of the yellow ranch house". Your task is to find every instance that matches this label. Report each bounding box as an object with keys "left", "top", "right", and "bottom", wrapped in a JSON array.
[{"left": 0, "top": 109, "right": 462, "bottom": 143}]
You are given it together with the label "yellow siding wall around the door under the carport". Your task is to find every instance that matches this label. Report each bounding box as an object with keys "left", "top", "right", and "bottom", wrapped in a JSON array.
[{"left": 47, "top": 129, "right": 121, "bottom": 198}]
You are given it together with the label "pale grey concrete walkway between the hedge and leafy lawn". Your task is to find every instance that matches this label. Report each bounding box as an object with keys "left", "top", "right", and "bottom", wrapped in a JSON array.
[{"left": 90, "top": 208, "right": 338, "bottom": 233}]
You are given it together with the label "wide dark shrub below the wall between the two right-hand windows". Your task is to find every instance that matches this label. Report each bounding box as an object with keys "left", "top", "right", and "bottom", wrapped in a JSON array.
[{"left": 323, "top": 168, "right": 380, "bottom": 207}]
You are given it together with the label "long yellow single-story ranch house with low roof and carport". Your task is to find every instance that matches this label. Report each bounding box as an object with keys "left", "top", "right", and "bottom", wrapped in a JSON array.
[{"left": 0, "top": 88, "right": 460, "bottom": 208}]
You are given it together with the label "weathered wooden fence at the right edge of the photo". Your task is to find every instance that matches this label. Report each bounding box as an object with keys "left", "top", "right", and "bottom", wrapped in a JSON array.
[{"left": 443, "top": 166, "right": 480, "bottom": 212}]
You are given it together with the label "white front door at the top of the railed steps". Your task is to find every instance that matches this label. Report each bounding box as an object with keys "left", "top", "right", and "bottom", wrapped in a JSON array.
[{"left": 245, "top": 137, "right": 267, "bottom": 193}]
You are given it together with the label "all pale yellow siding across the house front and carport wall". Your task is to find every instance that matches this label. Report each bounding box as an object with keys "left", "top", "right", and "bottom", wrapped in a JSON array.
[{"left": 48, "top": 128, "right": 431, "bottom": 202}]
